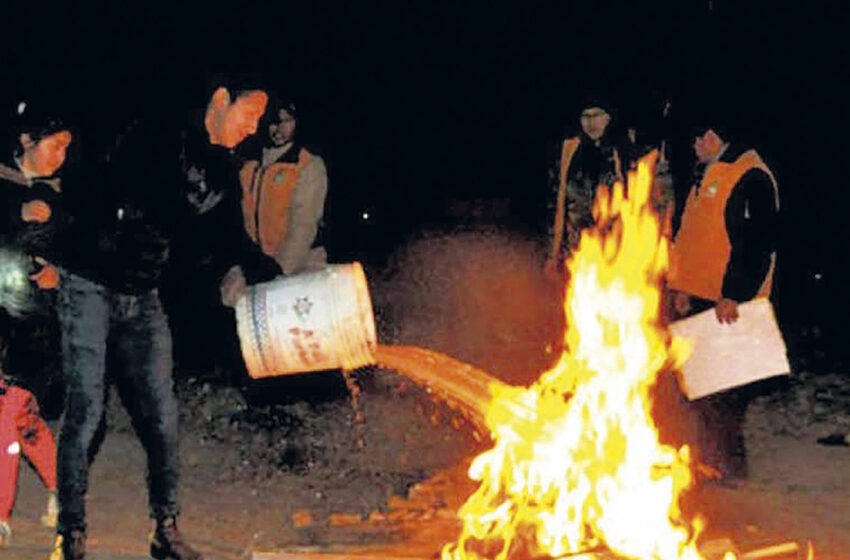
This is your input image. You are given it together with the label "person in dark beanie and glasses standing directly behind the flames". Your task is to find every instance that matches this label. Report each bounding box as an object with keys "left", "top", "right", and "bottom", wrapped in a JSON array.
[{"left": 545, "top": 97, "right": 628, "bottom": 274}]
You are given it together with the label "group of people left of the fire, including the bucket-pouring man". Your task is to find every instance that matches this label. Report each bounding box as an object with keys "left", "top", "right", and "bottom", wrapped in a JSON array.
[{"left": 0, "top": 86, "right": 327, "bottom": 560}]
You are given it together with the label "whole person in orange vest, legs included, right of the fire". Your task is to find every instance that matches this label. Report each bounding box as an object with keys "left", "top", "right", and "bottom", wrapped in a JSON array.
[{"left": 668, "top": 127, "right": 779, "bottom": 479}]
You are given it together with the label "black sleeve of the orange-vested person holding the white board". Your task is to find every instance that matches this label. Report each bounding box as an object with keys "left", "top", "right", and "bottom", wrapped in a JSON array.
[{"left": 722, "top": 169, "right": 778, "bottom": 302}]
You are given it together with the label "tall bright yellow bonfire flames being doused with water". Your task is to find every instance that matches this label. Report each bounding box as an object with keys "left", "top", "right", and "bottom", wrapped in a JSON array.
[{"left": 442, "top": 154, "right": 731, "bottom": 560}]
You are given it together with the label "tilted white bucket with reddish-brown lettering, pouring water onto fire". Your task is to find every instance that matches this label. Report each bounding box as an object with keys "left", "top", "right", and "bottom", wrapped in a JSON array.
[{"left": 236, "top": 262, "right": 376, "bottom": 378}]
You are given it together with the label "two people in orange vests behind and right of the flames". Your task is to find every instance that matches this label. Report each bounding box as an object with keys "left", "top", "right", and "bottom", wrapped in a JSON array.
[{"left": 545, "top": 99, "right": 779, "bottom": 480}]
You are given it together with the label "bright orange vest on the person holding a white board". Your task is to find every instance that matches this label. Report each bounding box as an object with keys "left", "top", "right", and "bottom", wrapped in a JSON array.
[{"left": 669, "top": 150, "right": 779, "bottom": 301}]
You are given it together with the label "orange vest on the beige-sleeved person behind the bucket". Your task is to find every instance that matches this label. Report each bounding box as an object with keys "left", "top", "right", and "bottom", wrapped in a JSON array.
[{"left": 239, "top": 148, "right": 310, "bottom": 257}]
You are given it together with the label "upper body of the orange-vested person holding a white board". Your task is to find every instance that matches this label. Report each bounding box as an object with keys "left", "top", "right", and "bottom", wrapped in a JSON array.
[{"left": 669, "top": 129, "right": 779, "bottom": 323}]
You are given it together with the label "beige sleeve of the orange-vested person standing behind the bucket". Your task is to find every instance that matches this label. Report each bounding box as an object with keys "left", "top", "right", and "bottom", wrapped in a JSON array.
[{"left": 276, "top": 155, "right": 328, "bottom": 274}]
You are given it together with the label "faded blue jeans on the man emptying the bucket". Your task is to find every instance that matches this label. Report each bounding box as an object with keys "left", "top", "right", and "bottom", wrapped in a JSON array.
[{"left": 57, "top": 271, "right": 179, "bottom": 533}]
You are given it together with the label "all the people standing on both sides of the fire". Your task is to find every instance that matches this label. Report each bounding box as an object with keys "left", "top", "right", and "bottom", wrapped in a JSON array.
[{"left": 0, "top": 87, "right": 779, "bottom": 560}]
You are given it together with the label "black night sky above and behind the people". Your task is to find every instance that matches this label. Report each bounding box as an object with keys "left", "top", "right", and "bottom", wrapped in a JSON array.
[{"left": 0, "top": 0, "right": 850, "bottom": 368}]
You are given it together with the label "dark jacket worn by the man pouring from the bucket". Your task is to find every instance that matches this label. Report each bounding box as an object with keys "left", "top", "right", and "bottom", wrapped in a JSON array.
[{"left": 47, "top": 118, "right": 274, "bottom": 294}]
